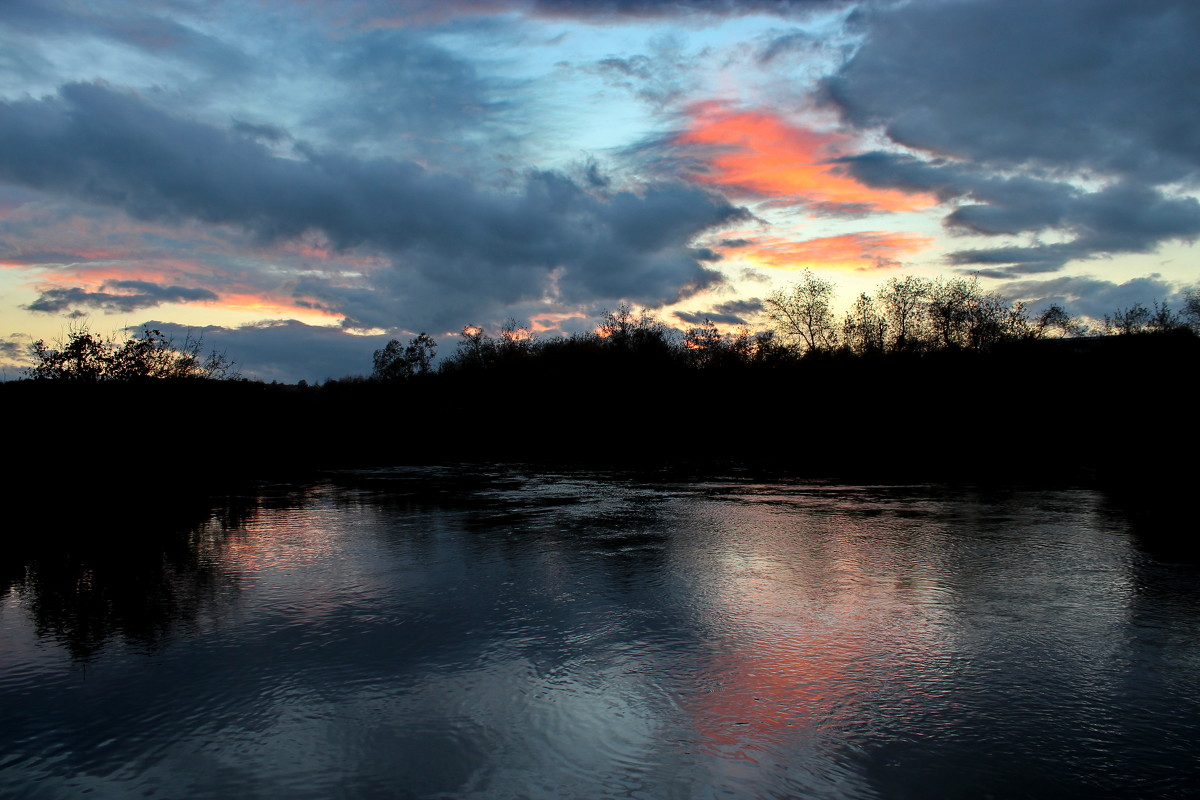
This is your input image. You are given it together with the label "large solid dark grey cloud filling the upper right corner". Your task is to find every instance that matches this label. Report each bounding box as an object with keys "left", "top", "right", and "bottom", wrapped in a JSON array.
[{"left": 827, "top": 0, "right": 1200, "bottom": 182}]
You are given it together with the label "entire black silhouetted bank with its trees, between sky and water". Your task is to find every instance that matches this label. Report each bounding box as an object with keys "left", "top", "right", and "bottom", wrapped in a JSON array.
[{"left": 11, "top": 273, "right": 1200, "bottom": 497}]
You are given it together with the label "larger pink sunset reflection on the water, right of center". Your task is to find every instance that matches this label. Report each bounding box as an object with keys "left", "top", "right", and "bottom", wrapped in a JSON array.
[{"left": 667, "top": 495, "right": 947, "bottom": 762}]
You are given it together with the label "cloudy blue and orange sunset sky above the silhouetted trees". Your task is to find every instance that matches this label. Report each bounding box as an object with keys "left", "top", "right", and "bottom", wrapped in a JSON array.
[{"left": 0, "top": 0, "right": 1200, "bottom": 381}]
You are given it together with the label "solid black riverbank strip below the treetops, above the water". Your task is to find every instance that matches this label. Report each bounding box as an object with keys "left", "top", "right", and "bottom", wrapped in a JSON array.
[{"left": 0, "top": 335, "right": 1200, "bottom": 501}]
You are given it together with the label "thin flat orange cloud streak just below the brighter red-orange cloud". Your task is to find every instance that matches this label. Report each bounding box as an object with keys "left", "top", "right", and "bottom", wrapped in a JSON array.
[{"left": 726, "top": 230, "right": 934, "bottom": 270}]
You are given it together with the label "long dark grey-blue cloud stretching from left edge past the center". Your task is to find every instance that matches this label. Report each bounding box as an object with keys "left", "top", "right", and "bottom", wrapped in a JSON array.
[{"left": 0, "top": 84, "right": 745, "bottom": 329}]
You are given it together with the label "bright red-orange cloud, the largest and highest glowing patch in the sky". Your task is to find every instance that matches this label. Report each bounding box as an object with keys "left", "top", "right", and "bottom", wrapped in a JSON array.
[{"left": 674, "top": 103, "right": 935, "bottom": 211}]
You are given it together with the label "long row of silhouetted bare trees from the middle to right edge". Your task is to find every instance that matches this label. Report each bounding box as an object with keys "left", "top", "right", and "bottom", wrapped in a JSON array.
[{"left": 371, "top": 270, "right": 1200, "bottom": 381}]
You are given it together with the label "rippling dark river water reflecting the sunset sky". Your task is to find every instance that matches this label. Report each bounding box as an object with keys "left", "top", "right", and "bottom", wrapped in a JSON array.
[{"left": 0, "top": 470, "right": 1200, "bottom": 798}]
